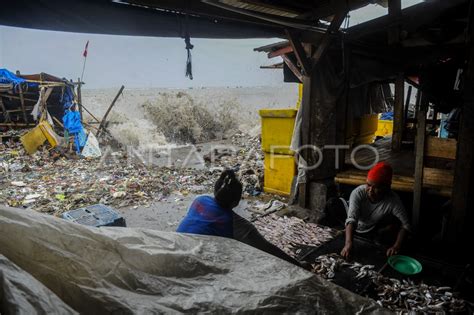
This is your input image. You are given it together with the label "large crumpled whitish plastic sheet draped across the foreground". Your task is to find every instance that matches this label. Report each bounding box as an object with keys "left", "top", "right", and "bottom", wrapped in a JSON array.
[{"left": 0, "top": 207, "right": 384, "bottom": 314}]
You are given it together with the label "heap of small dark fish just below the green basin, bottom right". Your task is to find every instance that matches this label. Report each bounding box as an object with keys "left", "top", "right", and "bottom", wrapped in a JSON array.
[{"left": 374, "top": 276, "right": 466, "bottom": 313}]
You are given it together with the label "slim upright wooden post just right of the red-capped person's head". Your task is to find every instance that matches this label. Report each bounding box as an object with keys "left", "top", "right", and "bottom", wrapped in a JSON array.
[{"left": 411, "top": 91, "right": 428, "bottom": 231}]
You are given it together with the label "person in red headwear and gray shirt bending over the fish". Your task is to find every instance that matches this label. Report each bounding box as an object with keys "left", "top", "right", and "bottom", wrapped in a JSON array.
[{"left": 326, "top": 162, "right": 410, "bottom": 258}]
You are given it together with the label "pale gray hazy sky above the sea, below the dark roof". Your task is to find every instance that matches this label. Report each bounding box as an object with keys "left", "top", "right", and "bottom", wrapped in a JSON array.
[{"left": 0, "top": 0, "right": 420, "bottom": 88}]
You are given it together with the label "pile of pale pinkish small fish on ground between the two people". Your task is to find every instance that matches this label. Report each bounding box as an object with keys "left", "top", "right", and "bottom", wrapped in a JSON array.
[{"left": 253, "top": 213, "right": 334, "bottom": 257}]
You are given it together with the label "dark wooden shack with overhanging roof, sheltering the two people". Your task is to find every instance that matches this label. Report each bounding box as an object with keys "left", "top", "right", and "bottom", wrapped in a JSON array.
[{"left": 0, "top": 0, "right": 474, "bottom": 244}]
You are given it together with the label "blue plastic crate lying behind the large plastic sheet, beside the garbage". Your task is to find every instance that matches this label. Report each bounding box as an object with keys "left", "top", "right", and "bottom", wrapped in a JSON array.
[{"left": 62, "top": 204, "right": 126, "bottom": 227}]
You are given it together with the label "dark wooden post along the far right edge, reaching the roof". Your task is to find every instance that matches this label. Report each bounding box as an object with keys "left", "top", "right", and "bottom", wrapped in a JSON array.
[{"left": 447, "top": 1, "right": 474, "bottom": 246}]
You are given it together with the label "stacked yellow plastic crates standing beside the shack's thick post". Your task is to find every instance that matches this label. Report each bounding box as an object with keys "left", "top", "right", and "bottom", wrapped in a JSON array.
[{"left": 259, "top": 108, "right": 297, "bottom": 196}]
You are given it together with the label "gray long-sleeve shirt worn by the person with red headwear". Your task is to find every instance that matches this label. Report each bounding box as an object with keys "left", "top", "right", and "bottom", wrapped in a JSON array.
[{"left": 346, "top": 185, "right": 410, "bottom": 233}]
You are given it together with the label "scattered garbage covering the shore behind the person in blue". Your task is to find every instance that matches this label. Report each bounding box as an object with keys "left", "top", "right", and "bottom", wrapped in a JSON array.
[{"left": 0, "top": 128, "right": 263, "bottom": 216}]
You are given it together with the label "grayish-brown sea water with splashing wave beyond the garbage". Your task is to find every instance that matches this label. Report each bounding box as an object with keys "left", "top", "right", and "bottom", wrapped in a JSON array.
[{"left": 82, "top": 83, "right": 298, "bottom": 150}]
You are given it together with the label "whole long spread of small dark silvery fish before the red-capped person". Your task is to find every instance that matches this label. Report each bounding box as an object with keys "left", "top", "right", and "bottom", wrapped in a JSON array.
[{"left": 312, "top": 254, "right": 466, "bottom": 313}]
